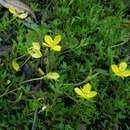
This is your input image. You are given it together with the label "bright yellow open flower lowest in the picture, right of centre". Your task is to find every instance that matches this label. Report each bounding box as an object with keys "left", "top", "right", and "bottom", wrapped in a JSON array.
[{"left": 74, "top": 83, "right": 97, "bottom": 100}]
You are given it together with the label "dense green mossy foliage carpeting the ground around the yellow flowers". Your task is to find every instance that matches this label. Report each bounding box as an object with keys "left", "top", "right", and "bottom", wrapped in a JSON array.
[{"left": 0, "top": 0, "right": 130, "bottom": 130}]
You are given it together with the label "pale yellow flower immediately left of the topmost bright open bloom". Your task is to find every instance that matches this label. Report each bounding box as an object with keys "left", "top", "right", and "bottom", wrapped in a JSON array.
[{"left": 28, "top": 42, "right": 42, "bottom": 58}]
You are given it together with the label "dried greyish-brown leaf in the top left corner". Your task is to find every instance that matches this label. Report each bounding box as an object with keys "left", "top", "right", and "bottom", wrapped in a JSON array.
[{"left": 0, "top": 0, "right": 36, "bottom": 20}]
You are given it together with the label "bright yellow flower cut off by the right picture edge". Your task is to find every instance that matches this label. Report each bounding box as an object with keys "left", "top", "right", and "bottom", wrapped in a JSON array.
[{"left": 111, "top": 62, "right": 130, "bottom": 78}]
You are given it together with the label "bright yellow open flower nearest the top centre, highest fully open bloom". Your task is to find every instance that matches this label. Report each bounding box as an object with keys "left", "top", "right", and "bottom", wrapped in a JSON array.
[{"left": 43, "top": 35, "right": 61, "bottom": 51}]
